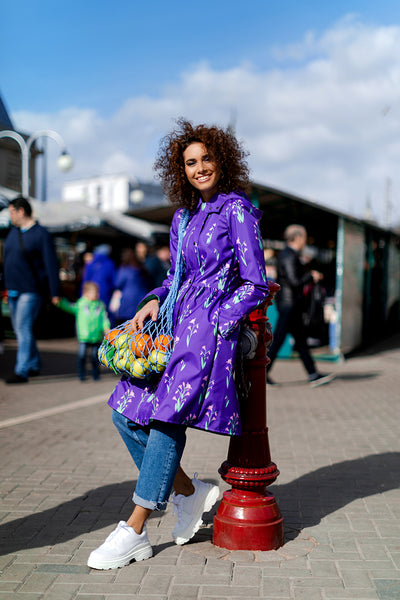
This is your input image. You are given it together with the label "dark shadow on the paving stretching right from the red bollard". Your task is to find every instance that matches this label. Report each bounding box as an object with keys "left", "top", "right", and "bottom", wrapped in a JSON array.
[{"left": 268, "top": 452, "right": 400, "bottom": 539}]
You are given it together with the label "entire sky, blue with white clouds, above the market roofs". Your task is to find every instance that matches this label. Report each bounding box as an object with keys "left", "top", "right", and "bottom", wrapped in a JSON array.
[{"left": 0, "top": 0, "right": 400, "bottom": 226}]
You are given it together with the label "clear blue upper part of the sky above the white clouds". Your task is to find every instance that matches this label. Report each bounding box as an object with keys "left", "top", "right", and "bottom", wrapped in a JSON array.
[{"left": 0, "top": 0, "right": 400, "bottom": 115}]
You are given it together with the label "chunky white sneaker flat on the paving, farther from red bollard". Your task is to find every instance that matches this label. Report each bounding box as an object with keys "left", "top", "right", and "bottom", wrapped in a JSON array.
[{"left": 87, "top": 521, "right": 153, "bottom": 570}]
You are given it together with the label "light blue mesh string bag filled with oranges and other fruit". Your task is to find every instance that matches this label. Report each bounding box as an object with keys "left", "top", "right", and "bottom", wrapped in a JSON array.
[{"left": 98, "top": 209, "right": 190, "bottom": 379}]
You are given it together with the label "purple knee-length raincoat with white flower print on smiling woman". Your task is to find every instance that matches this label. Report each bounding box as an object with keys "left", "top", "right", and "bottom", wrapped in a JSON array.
[{"left": 109, "top": 192, "right": 268, "bottom": 435}]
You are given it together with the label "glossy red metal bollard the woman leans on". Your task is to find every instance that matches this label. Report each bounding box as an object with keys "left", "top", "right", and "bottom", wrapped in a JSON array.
[{"left": 213, "top": 281, "right": 283, "bottom": 550}]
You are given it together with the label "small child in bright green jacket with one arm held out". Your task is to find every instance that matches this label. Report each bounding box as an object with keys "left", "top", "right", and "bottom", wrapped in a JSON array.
[{"left": 58, "top": 281, "right": 110, "bottom": 381}]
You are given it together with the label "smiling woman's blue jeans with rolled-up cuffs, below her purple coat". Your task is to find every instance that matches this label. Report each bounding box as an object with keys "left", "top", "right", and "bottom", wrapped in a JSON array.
[{"left": 112, "top": 410, "right": 186, "bottom": 510}]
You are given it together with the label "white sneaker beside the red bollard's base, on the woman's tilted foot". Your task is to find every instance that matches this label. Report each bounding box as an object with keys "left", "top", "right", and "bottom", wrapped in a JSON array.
[{"left": 172, "top": 473, "right": 219, "bottom": 546}]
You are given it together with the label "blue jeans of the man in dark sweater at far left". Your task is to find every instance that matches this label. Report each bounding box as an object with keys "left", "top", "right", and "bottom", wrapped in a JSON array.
[{"left": 8, "top": 292, "right": 42, "bottom": 377}]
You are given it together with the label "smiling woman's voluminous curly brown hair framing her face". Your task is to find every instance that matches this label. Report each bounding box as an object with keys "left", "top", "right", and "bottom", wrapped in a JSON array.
[{"left": 154, "top": 118, "right": 249, "bottom": 210}]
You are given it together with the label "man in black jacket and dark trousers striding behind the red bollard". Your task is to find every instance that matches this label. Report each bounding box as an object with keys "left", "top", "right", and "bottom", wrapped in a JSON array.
[{"left": 267, "top": 225, "right": 333, "bottom": 387}]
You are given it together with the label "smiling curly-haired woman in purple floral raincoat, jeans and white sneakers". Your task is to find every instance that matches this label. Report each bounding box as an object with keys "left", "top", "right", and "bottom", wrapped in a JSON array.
[{"left": 88, "top": 119, "right": 268, "bottom": 569}]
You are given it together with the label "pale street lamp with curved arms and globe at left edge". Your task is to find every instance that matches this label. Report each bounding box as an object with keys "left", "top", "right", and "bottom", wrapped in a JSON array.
[{"left": 0, "top": 129, "right": 73, "bottom": 198}]
